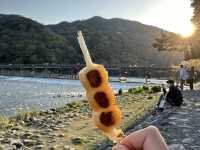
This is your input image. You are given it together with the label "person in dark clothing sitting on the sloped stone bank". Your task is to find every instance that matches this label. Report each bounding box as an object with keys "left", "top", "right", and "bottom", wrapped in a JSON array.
[{"left": 157, "top": 80, "right": 183, "bottom": 111}]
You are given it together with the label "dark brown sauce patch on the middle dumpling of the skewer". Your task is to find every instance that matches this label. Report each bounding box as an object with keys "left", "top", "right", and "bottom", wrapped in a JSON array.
[{"left": 94, "top": 92, "right": 110, "bottom": 108}]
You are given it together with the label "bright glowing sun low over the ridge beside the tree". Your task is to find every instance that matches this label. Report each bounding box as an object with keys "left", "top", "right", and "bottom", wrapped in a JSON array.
[{"left": 177, "top": 22, "right": 195, "bottom": 37}]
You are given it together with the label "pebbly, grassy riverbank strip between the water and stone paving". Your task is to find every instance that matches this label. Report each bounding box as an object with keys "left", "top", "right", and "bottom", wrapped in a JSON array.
[{"left": 0, "top": 88, "right": 159, "bottom": 150}]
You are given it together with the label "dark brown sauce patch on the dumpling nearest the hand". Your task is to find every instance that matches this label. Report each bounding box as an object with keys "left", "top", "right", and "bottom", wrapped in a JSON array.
[{"left": 100, "top": 111, "right": 115, "bottom": 127}]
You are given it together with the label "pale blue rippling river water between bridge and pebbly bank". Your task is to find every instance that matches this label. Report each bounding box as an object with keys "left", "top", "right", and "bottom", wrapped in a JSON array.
[{"left": 0, "top": 76, "right": 166, "bottom": 116}]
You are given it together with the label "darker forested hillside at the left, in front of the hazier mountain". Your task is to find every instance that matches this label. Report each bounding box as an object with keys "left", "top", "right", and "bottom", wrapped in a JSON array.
[{"left": 0, "top": 15, "right": 73, "bottom": 64}]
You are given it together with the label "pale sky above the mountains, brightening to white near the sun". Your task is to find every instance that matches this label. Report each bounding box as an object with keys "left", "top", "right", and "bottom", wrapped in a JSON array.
[{"left": 0, "top": 0, "right": 193, "bottom": 35}]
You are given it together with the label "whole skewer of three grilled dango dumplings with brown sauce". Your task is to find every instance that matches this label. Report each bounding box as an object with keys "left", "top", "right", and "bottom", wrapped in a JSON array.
[{"left": 78, "top": 31, "right": 123, "bottom": 141}]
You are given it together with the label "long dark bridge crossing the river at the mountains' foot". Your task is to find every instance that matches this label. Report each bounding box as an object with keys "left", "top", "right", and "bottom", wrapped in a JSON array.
[{"left": 0, "top": 64, "right": 177, "bottom": 78}]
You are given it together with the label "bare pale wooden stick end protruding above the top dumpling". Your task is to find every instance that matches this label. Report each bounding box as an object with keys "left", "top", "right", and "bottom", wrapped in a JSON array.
[{"left": 77, "top": 31, "right": 93, "bottom": 66}]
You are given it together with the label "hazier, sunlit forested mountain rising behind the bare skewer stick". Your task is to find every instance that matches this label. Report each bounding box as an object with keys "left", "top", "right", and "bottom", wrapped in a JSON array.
[{"left": 48, "top": 17, "right": 183, "bottom": 66}]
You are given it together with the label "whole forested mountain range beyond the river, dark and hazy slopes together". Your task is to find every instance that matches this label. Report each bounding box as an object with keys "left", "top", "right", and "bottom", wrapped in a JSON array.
[{"left": 0, "top": 15, "right": 182, "bottom": 66}]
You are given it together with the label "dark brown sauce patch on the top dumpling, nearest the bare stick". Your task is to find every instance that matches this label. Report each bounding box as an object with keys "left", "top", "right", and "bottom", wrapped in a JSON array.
[{"left": 87, "top": 70, "right": 102, "bottom": 88}]
